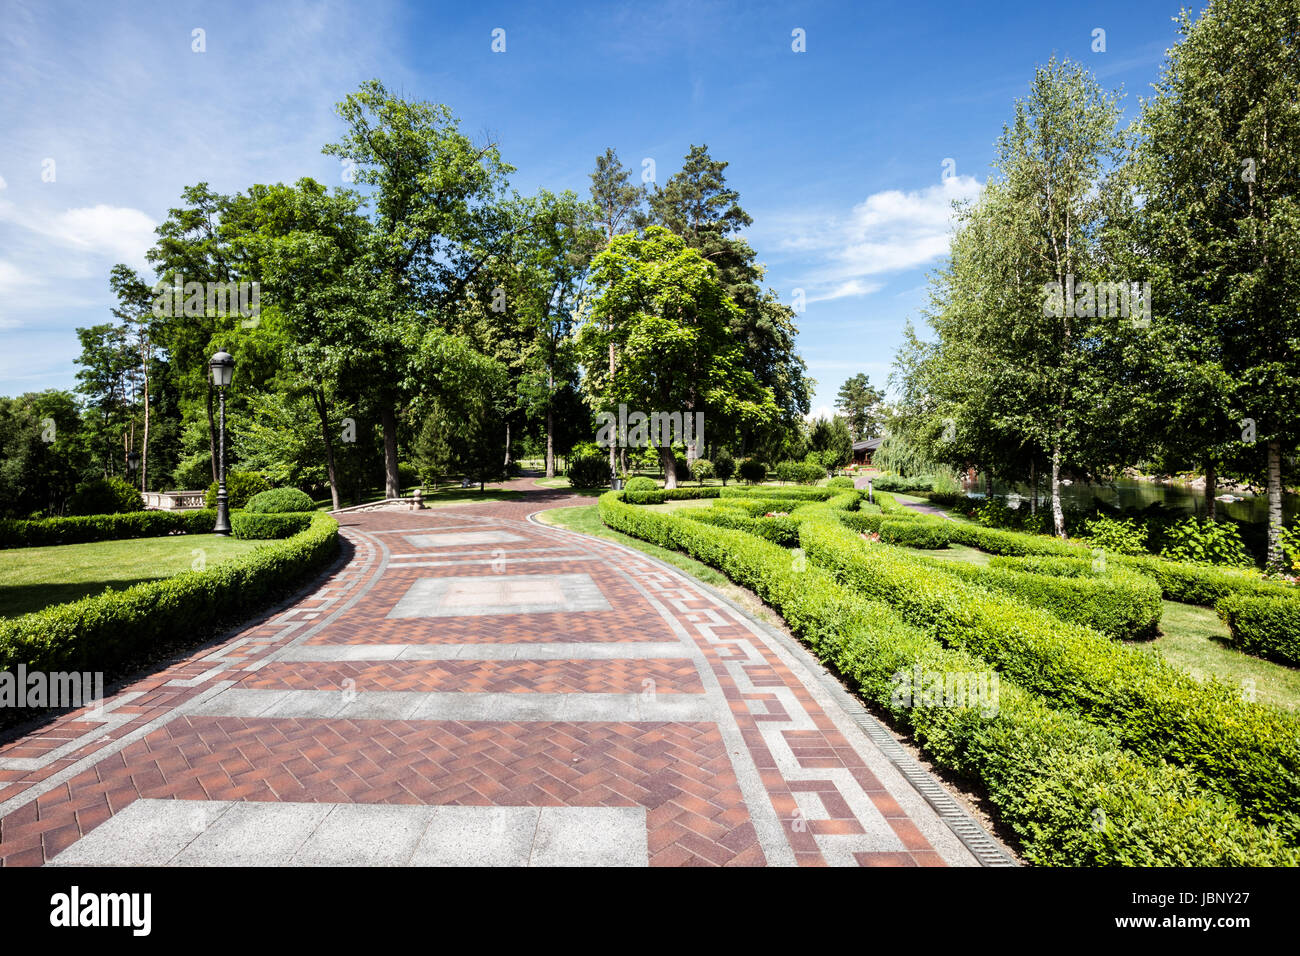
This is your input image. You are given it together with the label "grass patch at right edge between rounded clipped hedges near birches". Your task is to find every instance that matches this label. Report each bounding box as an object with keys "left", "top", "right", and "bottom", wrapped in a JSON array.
[{"left": 1139, "top": 601, "right": 1300, "bottom": 710}]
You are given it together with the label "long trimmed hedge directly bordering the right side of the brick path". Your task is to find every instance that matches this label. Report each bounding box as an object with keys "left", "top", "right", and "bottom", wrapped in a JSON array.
[{"left": 599, "top": 494, "right": 1296, "bottom": 866}]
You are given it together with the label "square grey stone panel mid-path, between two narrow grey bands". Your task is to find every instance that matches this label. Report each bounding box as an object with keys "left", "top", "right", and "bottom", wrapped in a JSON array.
[{"left": 387, "top": 574, "right": 610, "bottom": 618}]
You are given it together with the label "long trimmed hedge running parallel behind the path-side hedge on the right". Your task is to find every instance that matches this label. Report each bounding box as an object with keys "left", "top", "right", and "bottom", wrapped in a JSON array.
[{"left": 800, "top": 518, "right": 1300, "bottom": 842}]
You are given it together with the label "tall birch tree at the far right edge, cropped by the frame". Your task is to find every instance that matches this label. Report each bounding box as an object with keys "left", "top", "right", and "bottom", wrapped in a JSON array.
[{"left": 1136, "top": 0, "right": 1300, "bottom": 568}]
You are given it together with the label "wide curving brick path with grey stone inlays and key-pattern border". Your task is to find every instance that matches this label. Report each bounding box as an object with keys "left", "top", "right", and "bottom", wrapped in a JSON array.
[{"left": 0, "top": 480, "right": 1003, "bottom": 866}]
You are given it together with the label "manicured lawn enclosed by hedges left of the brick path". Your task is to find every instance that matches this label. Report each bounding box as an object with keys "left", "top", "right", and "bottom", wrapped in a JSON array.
[{"left": 0, "top": 535, "right": 267, "bottom": 618}]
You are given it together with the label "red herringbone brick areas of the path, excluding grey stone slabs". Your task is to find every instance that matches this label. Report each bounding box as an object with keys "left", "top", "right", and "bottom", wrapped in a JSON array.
[{"left": 0, "top": 481, "right": 967, "bottom": 866}]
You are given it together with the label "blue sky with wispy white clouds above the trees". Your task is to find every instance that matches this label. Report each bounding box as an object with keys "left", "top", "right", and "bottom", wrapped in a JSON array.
[{"left": 0, "top": 0, "right": 1200, "bottom": 408}]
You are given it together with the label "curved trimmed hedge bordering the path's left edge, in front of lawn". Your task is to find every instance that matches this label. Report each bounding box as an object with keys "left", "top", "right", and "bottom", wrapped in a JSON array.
[{"left": 0, "top": 514, "right": 338, "bottom": 672}]
